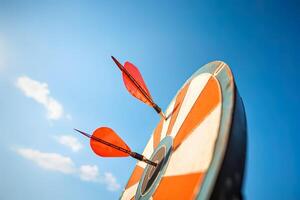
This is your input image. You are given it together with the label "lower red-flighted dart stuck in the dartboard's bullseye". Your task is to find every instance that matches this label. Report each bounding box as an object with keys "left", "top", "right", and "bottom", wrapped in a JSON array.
[{"left": 74, "top": 127, "right": 157, "bottom": 167}]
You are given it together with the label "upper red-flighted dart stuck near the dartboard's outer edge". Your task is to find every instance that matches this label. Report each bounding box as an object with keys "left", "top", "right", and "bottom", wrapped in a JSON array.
[{"left": 111, "top": 56, "right": 166, "bottom": 119}]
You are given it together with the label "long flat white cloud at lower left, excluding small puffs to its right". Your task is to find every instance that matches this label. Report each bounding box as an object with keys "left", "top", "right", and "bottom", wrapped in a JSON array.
[{"left": 17, "top": 148, "right": 76, "bottom": 174}]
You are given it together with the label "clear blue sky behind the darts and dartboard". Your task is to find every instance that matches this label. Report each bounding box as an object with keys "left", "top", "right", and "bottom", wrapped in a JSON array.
[{"left": 0, "top": 0, "right": 300, "bottom": 200}]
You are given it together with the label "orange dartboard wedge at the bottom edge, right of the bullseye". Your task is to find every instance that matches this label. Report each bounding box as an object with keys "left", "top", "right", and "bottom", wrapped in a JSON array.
[{"left": 153, "top": 172, "right": 204, "bottom": 200}]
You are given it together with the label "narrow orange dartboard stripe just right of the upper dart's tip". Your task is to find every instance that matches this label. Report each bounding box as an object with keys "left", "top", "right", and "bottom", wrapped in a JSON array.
[{"left": 167, "top": 82, "right": 190, "bottom": 135}]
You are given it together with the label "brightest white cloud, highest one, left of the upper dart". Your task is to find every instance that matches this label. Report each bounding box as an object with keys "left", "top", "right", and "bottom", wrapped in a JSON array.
[{"left": 16, "top": 76, "right": 64, "bottom": 120}]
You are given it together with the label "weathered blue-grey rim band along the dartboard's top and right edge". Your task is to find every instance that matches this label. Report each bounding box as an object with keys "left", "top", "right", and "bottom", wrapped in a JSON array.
[{"left": 196, "top": 61, "right": 235, "bottom": 200}]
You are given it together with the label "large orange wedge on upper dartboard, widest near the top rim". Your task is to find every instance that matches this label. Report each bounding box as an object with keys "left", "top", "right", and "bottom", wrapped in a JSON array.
[{"left": 173, "top": 77, "right": 221, "bottom": 149}]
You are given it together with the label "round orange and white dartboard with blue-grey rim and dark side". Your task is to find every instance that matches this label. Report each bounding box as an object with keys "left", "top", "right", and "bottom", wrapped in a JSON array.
[{"left": 121, "top": 61, "right": 247, "bottom": 200}]
